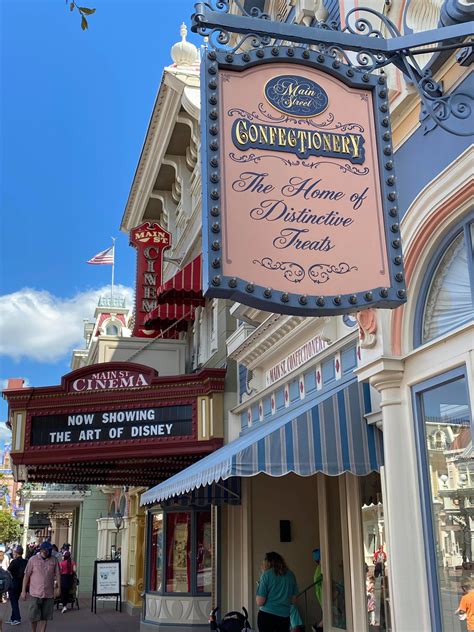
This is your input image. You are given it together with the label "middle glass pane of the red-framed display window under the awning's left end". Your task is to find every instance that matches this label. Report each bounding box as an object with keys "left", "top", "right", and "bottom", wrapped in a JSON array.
[{"left": 166, "top": 511, "right": 191, "bottom": 592}]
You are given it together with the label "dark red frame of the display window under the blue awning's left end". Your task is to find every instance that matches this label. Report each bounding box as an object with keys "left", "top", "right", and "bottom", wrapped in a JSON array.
[{"left": 146, "top": 506, "right": 212, "bottom": 597}]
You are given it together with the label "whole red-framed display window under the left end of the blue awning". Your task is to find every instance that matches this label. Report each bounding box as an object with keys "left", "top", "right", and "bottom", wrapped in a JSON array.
[{"left": 148, "top": 509, "right": 213, "bottom": 595}]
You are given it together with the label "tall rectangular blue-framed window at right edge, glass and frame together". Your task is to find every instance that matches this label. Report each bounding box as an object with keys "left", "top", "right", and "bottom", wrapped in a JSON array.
[{"left": 414, "top": 368, "right": 474, "bottom": 632}]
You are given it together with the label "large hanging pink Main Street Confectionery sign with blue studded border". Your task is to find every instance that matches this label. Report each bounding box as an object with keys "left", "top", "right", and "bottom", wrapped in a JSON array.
[{"left": 201, "top": 47, "right": 406, "bottom": 316}]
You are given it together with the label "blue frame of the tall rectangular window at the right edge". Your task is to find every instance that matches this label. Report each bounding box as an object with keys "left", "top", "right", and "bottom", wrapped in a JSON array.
[{"left": 411, "top": 364, "right": 474, "bottom": 632}]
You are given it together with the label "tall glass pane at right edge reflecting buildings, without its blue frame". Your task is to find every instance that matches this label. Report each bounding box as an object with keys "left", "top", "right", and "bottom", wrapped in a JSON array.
[{"left": 421, "top": 377, "right": 474, "bottom": 632}]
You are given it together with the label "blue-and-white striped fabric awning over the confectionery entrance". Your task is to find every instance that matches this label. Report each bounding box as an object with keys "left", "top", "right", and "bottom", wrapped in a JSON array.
[{"left": 141, "top": 381, "right": 383, "bottom": 505}]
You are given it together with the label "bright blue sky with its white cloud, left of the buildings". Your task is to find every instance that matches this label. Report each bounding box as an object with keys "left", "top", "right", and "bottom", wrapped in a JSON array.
[{"left": 0, "top": 0, "right": 202, "bottom": 422}]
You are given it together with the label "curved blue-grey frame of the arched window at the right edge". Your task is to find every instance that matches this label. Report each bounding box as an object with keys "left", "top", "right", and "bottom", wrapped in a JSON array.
[{"left": 413, "top": 215, "right": 474, "bottom": 349}]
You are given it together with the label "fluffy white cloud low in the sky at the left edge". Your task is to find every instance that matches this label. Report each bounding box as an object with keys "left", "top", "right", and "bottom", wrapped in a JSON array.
[{"left": 0, "top": 285, "right": 134, "bottom": 362}]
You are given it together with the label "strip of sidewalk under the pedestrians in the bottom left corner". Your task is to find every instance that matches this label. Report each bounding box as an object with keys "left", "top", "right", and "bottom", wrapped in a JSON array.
[{"left": 3, "top": 599, "right": 140, "bottom": 632}]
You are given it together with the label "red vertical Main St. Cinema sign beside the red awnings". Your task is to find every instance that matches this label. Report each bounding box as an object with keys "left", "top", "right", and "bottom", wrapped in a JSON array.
[{"left": 130, "top": 222, "right": 171, "bottom": 338}]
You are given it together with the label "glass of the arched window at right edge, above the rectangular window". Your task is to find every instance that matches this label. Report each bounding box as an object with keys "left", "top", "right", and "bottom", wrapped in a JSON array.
[{"left": 423, "top": 233, "right": 474, "bottom": 342}]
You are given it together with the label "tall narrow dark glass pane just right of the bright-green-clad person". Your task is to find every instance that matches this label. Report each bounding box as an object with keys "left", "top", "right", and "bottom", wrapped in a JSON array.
[{"left": 326, "top": 476, "right": 346, "bottom": 630}]
